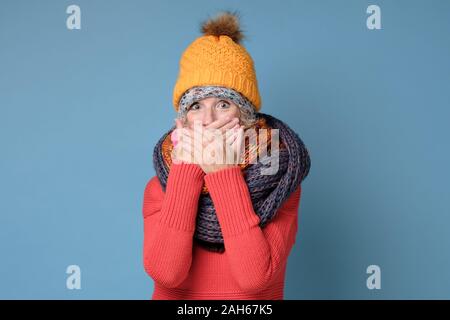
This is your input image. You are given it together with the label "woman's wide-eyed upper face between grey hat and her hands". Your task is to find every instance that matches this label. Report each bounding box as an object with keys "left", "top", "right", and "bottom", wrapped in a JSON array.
[{"left": 186, "top": 97, "right": 241, "bottom": 128}]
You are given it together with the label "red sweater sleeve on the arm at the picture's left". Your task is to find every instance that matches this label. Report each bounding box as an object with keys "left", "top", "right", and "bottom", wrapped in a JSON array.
[{"left": 142, "top": 163, "right": 205, "bottom": 288}]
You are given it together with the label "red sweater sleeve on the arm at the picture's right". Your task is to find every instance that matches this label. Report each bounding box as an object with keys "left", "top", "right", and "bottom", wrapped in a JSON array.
[{"left": 205, "top": 167, "right": 301, "bottom": 291}]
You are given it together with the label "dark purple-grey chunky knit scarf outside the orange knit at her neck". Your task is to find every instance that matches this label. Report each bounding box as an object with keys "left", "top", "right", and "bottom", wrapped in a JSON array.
[{"left": 153, "top": 112, "right": 311, "bottom": 253}]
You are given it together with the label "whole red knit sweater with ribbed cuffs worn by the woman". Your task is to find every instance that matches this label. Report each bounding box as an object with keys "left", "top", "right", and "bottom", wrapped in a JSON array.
[{"left": 143, "top": 163, "right": 301, "bottom": 300}]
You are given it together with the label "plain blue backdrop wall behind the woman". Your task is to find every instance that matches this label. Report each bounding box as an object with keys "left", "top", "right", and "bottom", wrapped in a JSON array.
[{"left": 0, "top": 0, "right": 450, "bottom": 299}]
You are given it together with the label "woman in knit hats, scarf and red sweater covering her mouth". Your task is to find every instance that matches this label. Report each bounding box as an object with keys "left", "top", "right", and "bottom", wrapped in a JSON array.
[{"left": 143, "top": 12, "right": 310, "bottom": 300}]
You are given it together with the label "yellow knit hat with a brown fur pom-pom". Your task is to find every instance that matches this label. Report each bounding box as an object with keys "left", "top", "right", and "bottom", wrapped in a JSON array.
[{"left": 173, "top": 12, "right": 261, "bottom": 112}]
